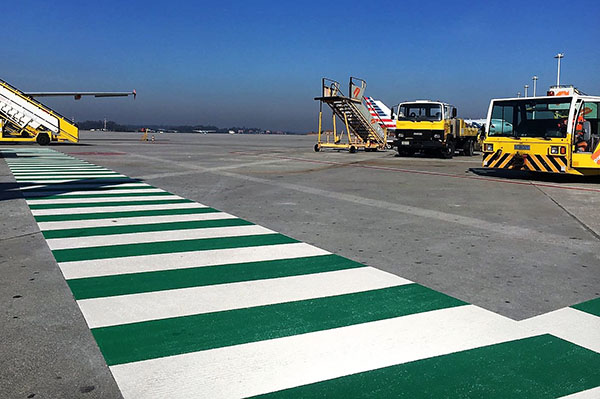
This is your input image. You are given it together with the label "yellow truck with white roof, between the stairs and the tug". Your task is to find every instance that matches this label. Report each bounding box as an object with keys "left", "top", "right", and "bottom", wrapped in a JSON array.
[{"left": 390, "top": 100, "right": 479, "bottom": 158}]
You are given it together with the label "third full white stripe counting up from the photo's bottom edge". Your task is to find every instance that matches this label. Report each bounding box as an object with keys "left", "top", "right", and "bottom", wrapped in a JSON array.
[{"left": 59, "top": 242, "right": 329, "bottom": 280}]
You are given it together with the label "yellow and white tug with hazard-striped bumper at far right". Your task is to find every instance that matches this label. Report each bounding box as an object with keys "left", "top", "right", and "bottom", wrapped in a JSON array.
[{"left": 483, "top": 86, "right": 600, "bottom": 176}]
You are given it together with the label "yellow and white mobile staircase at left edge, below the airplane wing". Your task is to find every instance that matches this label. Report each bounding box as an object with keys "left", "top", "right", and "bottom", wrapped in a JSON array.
[{"left": 0, "top": 80, "right": 79, "bottom": 145}]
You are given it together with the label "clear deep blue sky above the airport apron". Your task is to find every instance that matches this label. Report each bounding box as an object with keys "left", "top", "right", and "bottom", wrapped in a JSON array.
[{"left": 5, "top": 0, "right": 600, "bottom": 132}]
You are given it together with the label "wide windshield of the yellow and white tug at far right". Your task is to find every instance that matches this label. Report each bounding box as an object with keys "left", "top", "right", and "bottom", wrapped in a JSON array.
[{"left": 488, "top": 97, "right": 571, "bottom": 138}]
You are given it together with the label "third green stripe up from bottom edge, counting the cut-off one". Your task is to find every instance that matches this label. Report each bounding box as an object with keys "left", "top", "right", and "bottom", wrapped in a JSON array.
[{"left": 68, "top": 255, "right": 365, "bottom": 300}]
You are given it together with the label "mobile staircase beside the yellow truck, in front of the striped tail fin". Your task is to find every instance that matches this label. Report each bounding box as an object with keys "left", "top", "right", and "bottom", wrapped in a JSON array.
[{"left": 314, "top": 77, "right": 387, "bottom": 153}]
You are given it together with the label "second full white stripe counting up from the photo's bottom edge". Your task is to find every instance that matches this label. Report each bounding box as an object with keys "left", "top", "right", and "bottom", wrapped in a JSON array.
[{"left": 77, "top": 267, "right": 411, "bottom": 328}]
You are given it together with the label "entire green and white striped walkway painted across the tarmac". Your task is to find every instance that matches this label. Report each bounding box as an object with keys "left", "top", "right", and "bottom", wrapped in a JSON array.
[{"left": 0, "top": 148, "right": 600, "bottom": 398}]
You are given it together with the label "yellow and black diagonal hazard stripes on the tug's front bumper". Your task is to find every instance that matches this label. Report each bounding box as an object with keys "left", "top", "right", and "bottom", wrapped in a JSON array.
[{"left": 483, "top": 151, "right": 567, "bottom": 173}]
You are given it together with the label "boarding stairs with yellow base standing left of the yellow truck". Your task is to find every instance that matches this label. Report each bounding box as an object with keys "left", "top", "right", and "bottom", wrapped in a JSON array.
[{"left": 315, "top": 77, "right": 387, "bottom": 151}]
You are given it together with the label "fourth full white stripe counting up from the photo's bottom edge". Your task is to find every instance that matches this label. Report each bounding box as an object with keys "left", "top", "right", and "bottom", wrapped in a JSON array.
[{"left": 46, "top": 225, "right": 275, "bottom": 250}]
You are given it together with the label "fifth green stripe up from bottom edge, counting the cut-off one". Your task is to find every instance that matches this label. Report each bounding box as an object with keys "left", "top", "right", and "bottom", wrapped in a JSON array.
[{"left": 42, "top": 219, "right": 253, "bottom": 239}]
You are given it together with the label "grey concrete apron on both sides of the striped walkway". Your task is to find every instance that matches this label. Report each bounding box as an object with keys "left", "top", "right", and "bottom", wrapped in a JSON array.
[{"left": 0, "top": 132, "right": 600, "bottom": 397}]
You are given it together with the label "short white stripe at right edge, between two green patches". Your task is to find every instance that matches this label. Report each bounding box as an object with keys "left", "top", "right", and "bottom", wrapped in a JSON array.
[{"left": 519, "top": 308, "right": 600, "bottom": 353}]
